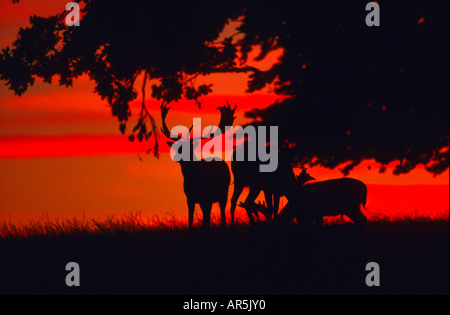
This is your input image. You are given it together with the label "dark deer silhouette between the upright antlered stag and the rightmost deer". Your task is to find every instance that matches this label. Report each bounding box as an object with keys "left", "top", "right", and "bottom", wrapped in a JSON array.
[{"left": 230, "top": 139, "right": 296, "bottom": 225}]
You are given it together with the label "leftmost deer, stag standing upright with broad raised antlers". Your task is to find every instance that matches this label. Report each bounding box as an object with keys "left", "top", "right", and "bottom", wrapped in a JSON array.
[{"left": 161, "top": 102, "right": 236, "bottom": 229}]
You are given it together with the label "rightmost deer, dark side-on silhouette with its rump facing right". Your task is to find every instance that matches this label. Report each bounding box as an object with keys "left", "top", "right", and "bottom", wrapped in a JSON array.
[{"left": 279, "top": 169, "right": 367, "bottom": 225}]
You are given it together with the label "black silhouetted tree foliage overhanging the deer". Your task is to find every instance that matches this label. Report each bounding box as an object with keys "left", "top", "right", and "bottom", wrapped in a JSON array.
[{"left": 0, "top": 0, "right": 449, "bottom": 175}]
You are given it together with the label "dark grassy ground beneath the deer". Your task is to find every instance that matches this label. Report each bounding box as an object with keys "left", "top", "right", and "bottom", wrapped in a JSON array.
[{"left": 0, "top": 216, "right": 449, "bottom": 295}]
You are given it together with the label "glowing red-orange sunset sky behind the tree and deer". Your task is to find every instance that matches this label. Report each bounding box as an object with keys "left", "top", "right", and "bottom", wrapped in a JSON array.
[{"left": 0, "top": 0, "right": 449, "bottom": 226}]
